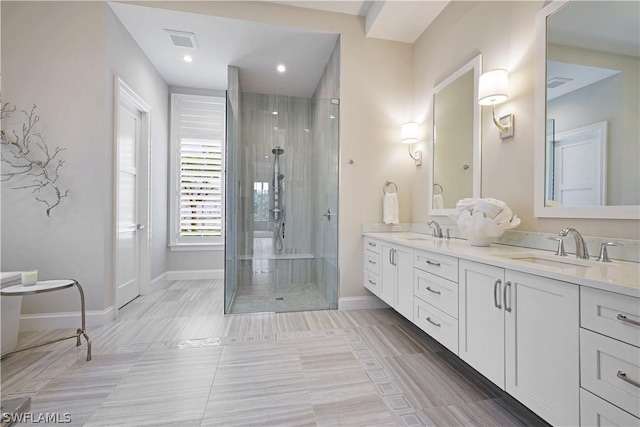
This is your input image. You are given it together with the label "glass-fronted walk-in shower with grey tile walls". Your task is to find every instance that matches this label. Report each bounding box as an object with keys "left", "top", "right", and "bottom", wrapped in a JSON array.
[{"left": 225, "top": 91, "right": 339, "bottom": 314}]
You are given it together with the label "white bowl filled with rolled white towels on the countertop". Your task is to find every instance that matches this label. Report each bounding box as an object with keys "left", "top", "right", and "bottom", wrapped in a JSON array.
[{"left": 451, "top": 198, "right": 520, "bottom": 246}]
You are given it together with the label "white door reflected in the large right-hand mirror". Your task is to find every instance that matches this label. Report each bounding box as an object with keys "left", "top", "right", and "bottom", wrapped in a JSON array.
[{"left": 553, "top": 122, "right": 607, "bottom": 206}]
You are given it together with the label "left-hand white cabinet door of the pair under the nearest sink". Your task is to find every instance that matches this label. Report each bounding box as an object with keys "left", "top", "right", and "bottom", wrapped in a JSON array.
[{"left": 458, "top": 260, "right": 504, "bottom": 388}]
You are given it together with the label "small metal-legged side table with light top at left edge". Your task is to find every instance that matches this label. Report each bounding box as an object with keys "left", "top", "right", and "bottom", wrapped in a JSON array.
[{"left": 0, "top": 279, "right": 91, "bottom": 361}]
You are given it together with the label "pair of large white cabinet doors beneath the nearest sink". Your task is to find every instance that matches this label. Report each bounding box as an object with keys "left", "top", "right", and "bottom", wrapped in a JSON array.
[{"left": 459, "top": 260, "right": 579, "bottom": 426}]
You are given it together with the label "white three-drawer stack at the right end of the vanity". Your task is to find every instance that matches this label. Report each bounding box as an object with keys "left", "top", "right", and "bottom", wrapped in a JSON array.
[{"left": 580, "top": 286, "right": 640, "bottom": 426}]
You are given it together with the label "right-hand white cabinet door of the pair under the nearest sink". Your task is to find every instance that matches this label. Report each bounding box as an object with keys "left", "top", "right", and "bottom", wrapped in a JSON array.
[{"left": 504, "top": 270, "right": 580, "bottom": 426}]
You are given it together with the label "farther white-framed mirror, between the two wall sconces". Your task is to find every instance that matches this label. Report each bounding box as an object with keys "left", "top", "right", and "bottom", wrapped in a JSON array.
[{"left": 428, "top": 55, "right": 482, "bottom": 216}]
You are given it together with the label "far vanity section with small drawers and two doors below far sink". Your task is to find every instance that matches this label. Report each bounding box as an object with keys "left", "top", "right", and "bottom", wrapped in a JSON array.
[{"left": 364, "top": 238, "right": 413, "bottom": 320}]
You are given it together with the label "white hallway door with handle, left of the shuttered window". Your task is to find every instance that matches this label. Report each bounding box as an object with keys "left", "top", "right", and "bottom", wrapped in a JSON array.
[{"left": 116, "top": 98, "right": 142, "bottom": 308}]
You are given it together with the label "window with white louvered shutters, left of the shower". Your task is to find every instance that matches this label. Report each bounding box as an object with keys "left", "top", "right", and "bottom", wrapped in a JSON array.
[{"left": 170, "top": 93, "right": 226, "bottom": 246}]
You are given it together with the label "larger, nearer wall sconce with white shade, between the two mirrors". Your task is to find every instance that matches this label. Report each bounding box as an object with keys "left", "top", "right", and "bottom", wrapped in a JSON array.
[{"left": 478, "top": 70, "right": 513, "bottom": 139}]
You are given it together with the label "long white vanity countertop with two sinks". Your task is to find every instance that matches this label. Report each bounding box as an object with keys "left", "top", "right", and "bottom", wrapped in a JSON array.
[{"left": 363, "top": 232, "right": 640, "bottom": 297}]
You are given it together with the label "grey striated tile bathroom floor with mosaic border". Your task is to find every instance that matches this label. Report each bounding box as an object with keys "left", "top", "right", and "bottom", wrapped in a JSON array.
[{"left": 0, "top": 281, "right": 546, "bottom": 426}]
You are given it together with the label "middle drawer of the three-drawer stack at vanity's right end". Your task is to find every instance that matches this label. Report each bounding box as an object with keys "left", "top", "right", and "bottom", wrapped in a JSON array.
[{"left": 580, "top": 329, "right": 640, "bottom": 417}]
